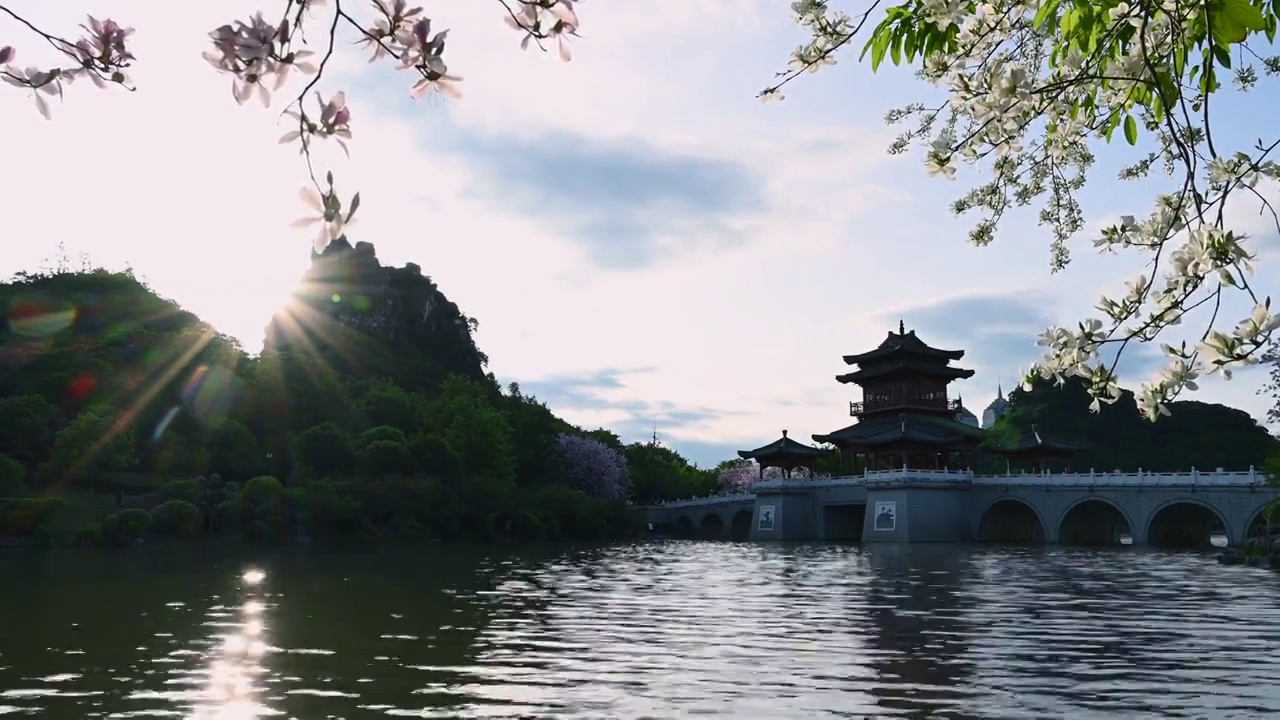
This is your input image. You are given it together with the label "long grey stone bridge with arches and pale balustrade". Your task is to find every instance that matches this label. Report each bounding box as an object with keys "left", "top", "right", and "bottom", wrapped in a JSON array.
[{"left": 646, "top": 468, "right": 1280, "bottom": 547}]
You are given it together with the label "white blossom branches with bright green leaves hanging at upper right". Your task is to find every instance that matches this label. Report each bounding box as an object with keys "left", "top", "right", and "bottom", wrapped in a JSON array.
[{"left": 778, "top": 0, "right": 1280, "bottom": 419}]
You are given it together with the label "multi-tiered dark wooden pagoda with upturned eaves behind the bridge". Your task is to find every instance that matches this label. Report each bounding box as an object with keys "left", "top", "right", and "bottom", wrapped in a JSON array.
[{"left": 813, "top": 322, "right": 986, "bottom": 470}]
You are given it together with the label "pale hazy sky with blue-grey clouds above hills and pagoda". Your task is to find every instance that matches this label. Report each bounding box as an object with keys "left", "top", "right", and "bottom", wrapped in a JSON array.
[{"left": 0, "top": 0, "right": 1280, "bottom": 465}]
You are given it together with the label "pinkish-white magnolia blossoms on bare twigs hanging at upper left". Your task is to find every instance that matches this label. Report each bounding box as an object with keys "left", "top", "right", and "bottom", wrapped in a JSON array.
[{"left": 0, "top": 0, "right": 580, "bottom": 245}]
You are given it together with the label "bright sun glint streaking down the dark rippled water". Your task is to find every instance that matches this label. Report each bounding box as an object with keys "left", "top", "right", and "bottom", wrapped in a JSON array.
[{"left": 188, "top": 570, "right": 276, "bottom": 720}]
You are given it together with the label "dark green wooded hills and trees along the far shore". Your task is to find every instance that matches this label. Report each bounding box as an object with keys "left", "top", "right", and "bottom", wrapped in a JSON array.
[{"left": 0, "top": 240, "right": 1277, "bottom": 555}]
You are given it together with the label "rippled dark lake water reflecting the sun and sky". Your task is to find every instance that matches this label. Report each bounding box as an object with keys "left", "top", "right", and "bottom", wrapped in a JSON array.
[{"left": 0, "top": 542, "right": 1280, "bottom": 720}]
